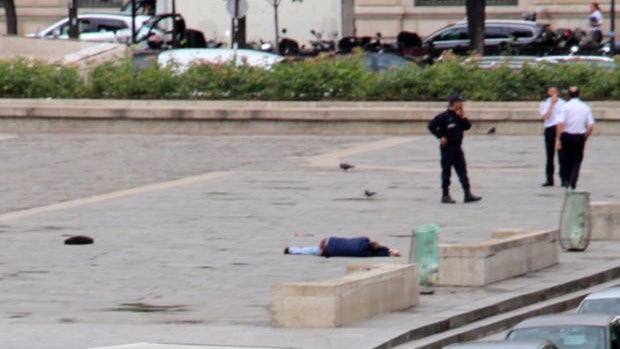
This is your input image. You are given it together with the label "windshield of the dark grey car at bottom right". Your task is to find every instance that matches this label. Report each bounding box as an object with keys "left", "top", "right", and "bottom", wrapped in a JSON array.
[{"left": 507, "top": 325, "right": 608, "bottom": 349}]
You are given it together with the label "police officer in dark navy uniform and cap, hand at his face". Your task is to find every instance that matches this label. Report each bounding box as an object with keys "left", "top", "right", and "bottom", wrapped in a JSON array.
[{"left": 428, "top": 95, "right": 482, "bottom": 204}]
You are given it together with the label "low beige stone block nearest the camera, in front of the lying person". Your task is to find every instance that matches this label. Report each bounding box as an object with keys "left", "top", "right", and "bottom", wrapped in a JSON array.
[{"left": 271, "top": 264, "right": 419, "bottom": 327}]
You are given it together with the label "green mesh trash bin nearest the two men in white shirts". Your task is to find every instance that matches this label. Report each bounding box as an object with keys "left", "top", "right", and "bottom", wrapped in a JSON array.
[{"left": 560, "top": 190, "right": 590, "bottom": 251}]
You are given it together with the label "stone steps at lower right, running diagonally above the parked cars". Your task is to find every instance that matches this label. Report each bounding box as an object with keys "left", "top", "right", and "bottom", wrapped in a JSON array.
[{"left": 373, "top": 266, "right": 620, "bottom": 349}]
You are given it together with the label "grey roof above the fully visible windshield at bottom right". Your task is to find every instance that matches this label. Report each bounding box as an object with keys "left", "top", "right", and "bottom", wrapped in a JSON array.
[{"left": 513, "top": 313, "right": 620, "bottom": 330}]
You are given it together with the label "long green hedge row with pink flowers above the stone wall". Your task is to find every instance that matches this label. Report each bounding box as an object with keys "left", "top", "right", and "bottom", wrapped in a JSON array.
[{"left": 0, "top": 56, "right": 620, "bottom": 101}]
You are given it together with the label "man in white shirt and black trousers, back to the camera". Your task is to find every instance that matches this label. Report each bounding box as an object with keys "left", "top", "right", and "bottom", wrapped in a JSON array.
[{"left": 556, "top": 86, "right": 594, "bottom": 189}]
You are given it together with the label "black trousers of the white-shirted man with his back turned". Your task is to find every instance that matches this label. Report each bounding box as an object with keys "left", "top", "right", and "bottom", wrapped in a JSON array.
[{"left": 560, "top": 133, "right": 586, "bottom": 189}]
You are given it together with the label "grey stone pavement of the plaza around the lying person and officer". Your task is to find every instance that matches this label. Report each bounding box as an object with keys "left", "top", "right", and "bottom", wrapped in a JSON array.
[{"left": 0, "top": 134, "right": 620, "bottom": 349}]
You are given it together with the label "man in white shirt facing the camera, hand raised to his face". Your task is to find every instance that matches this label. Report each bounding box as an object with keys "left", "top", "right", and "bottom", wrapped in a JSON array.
[{"left": 539, "top": 85, "right": 566, "bottom": 187}]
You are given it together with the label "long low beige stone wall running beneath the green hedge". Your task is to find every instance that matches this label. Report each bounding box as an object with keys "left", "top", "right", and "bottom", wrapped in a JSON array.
[{"left": 0, "top": 99, "right": 620, "bottom": 135}]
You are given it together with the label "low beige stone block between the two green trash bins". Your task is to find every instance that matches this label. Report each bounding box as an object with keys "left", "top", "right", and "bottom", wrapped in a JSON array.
[{"left": 438, "top": 230, "right": 559, "bottom": 286}]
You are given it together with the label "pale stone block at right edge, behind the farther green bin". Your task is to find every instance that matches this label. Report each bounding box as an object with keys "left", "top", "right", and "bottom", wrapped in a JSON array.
[{"left": 590, "top": 202, "right": 620, "bottom": 240}]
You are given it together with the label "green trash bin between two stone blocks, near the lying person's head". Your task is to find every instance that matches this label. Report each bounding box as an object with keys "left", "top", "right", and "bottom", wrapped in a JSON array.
[{"left": 409, "top": 224, "right": 439, "bottom": 286}]
